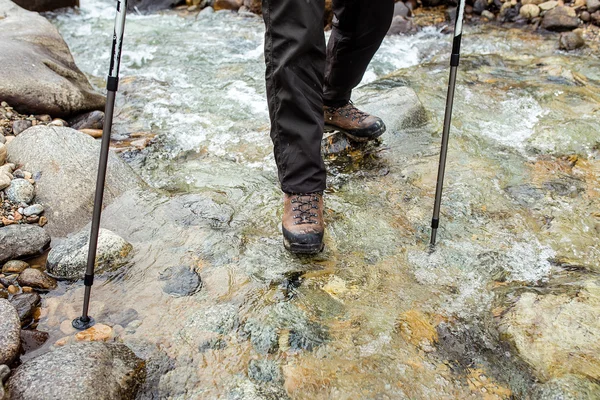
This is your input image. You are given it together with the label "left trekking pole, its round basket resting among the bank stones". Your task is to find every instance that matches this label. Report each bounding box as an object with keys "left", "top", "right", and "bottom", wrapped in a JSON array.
[{"left": 73, "top": 0, "right": 127, "bottom": 330}]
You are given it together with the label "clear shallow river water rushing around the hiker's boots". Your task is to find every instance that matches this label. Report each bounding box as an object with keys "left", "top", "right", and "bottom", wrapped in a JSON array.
[{"left": 40, "top": 0, "right": 600, "bottom": 399}]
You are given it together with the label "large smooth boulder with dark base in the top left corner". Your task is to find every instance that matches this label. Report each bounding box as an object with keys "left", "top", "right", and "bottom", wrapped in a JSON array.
[{"left": 0, "top": 0, "right": 105, "bottom": 117}]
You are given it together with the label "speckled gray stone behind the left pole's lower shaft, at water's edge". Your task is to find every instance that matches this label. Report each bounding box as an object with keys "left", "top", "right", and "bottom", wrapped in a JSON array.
[{"left": 46, "top": 229, "right": 133, "bottom": 279}]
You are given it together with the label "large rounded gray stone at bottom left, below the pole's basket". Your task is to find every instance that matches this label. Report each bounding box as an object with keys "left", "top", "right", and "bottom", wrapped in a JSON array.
[{"left": 7, "top": 342, "right": 146, "bottom": 400}]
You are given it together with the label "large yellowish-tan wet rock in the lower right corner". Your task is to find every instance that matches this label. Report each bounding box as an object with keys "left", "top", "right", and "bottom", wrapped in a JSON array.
[{"left": 499, "top": 280, "right": 600, "bottom": 381}]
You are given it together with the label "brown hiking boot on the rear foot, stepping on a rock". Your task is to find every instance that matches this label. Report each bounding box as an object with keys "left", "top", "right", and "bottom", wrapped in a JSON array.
[{"left": 323, "top": 102, "right": 385, "bottom": 142}]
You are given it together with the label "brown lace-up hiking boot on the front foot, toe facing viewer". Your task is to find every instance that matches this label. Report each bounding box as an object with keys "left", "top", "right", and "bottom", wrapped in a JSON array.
[{"left": 282, "top": 193, "right": 325, "bottom": 254}]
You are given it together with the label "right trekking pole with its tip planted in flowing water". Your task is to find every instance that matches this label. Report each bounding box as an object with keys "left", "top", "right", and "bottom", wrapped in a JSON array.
[{"left": 430, "top": 0, "right": 465, "bottom": 247}]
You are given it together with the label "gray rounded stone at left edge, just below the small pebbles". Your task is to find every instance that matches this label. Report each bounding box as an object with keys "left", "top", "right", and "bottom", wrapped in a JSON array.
[{"left": 0, "top": 224, "right": 50, "bottom": 263}]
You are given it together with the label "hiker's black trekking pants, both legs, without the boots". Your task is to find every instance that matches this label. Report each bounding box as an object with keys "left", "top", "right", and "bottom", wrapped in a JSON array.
[{"left": 262, "top": 0, "right": 394, "bottom": 193}]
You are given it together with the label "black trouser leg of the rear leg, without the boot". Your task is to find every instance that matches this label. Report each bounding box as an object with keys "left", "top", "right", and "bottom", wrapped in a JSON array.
[{"left": 323, "top": 0, "right": 394, "bottom": 107}]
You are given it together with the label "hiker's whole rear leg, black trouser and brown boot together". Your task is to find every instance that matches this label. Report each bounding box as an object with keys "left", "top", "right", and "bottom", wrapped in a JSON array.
[{"left": 323, "top": 0, "right": 394, "bottom": 141}]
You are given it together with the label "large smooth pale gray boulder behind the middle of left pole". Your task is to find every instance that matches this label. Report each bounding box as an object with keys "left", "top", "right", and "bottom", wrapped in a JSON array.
[{"left": 6, "top": 126, "right": 141, "bottom": 237}]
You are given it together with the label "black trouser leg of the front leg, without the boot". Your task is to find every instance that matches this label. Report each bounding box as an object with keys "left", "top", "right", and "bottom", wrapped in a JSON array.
[{"left": 262, "top": 0, "right": 325, "bottom": 193}]
